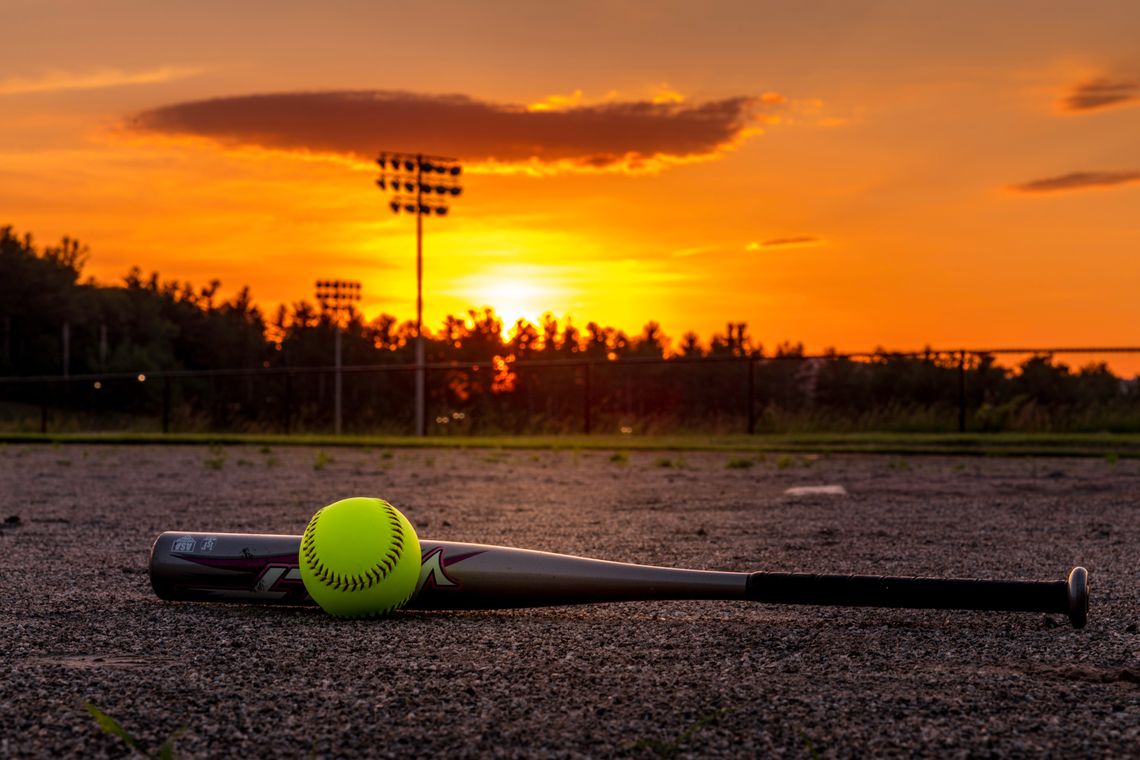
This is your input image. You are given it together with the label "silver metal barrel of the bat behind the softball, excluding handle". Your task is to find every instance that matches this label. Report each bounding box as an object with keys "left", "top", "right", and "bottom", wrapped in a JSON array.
[{"left": 150, "top": 531, "right": 749, "bottom": 610}]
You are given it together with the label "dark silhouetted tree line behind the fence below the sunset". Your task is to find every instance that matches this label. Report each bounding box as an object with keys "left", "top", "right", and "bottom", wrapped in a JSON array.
[{"left": 0, "top": 227, "right": 1140, "bottom": 432}]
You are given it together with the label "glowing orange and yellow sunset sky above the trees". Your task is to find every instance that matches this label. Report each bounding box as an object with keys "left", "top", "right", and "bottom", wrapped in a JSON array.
[{"left": 0, "top": 0, "right": 1140, "bottom": 351}]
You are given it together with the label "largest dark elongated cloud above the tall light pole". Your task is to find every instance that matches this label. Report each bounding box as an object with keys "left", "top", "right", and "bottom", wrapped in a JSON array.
[{"left": 127, "top": 91, "right": 783, "bottom": 172}]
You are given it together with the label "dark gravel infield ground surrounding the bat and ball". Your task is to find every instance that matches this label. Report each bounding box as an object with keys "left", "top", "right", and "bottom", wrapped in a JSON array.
[{"left": 0, "top": 446, "right": 1140, "bottom": 757}]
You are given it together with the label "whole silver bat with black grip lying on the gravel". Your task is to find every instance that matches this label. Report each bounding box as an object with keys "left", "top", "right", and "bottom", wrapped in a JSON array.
[{"left": 149, "top": 531, "right": 1089, "bottom": 628}]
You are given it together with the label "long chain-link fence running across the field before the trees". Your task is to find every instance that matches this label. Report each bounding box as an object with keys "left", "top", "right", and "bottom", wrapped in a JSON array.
[{"left": 0, "top": 348, "right": 1140, "bottom": 435}]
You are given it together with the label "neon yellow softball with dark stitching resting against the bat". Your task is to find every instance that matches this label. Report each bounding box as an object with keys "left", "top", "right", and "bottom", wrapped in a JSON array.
[{"left": 300, "top": 497, "right": 420, "bottom": 618}]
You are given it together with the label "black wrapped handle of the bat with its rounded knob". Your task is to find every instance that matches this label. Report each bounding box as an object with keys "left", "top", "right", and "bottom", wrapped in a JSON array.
[{"left": 746, "top": 567, "right": 1089, "bottom": 628}]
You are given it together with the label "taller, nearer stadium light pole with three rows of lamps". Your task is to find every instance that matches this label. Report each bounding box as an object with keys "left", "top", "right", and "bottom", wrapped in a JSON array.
[{"left": 376, "top": 153, "right": 463, "bottom": 435}]
